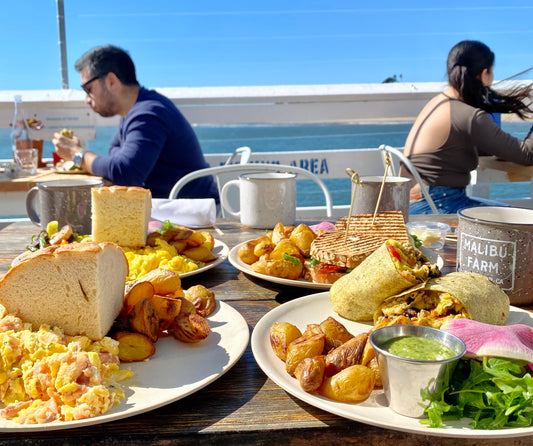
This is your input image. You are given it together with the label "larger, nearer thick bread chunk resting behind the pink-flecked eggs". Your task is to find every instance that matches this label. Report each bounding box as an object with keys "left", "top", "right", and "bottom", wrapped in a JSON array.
[{"left": 0, "top": 242, "right": 128, "bottom": 339}]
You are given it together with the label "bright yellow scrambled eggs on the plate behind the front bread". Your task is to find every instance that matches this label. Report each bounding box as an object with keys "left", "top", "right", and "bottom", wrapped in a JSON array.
[{"left": 122, "top": 238, "right": 205, "bottom": 280}]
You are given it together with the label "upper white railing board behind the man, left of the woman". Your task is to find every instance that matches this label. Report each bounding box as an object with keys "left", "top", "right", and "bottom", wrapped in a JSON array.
[{"left": 0, "top": 83, "right": 444, "bottom": 139}]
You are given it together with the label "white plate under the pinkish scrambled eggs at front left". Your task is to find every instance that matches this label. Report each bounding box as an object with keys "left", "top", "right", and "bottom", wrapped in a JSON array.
[{"left": 0, "top": 301, "right": 249, "bottom": 432}]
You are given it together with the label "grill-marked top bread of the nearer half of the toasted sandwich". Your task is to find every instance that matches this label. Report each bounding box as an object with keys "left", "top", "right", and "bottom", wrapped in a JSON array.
[{"left": 311, "top": 231, "right": 383, "bottom": 268}]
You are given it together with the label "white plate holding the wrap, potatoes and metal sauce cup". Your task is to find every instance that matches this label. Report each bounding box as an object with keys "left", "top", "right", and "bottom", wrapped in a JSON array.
[{"left": 251, "top": 292, "right": 533, "bottom": 438}]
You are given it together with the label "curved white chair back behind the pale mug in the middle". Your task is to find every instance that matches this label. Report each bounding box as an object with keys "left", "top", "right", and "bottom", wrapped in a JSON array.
[{"left": 168, "top": 163, "right": 333, "bottom": 217}]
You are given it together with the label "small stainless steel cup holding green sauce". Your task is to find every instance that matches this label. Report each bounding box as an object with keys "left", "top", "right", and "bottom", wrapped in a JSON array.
[{"left": 370, "top": 325, "right": 466, "bottom": 418}]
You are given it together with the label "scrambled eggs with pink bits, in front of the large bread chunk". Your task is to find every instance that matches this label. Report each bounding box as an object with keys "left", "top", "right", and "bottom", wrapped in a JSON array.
[{"left": 0, "top": 308, "right": 134, "bottom": 424}]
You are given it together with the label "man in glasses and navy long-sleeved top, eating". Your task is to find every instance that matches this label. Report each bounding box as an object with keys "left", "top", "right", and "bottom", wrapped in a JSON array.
[{"left": 52, "top": 45, "right": 218, "bottom": 203}]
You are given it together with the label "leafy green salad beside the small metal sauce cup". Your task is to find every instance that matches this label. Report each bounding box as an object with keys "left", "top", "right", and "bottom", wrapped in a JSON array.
[{"left": 421, "top": 357, "right": 533, "bottom": 429}]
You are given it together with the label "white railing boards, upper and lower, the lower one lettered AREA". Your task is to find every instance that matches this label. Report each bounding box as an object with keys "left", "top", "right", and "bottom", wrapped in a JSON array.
[{"left": 0, "top": 81, "right": 531, "bottom": 220}]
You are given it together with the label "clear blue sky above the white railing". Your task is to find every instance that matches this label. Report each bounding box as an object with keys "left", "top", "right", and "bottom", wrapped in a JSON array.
[{"left": 0, "top": 0, "right": 533, "bottom": 90}]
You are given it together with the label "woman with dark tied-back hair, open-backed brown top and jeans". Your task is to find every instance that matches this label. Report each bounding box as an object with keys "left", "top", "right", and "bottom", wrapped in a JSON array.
[{"left": 400, "top": 40, "right": 533, "bottom": 214}]
